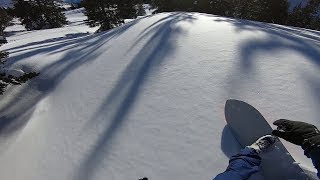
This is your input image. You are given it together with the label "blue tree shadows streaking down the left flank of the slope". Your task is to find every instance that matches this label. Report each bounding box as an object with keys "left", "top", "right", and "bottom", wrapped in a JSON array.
[{"left": 0, "top": 17, "right": 142, "bottom": 137}]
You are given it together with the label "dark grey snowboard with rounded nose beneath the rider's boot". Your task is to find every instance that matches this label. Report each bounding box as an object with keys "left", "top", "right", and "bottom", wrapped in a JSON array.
[{"left": 225, "top": 99, "right": 317, "bottom": 180}]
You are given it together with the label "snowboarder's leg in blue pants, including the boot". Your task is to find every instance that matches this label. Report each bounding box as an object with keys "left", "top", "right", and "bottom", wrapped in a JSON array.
[{"left": 214, "top": 135, "right": 277, "bottom": 180}]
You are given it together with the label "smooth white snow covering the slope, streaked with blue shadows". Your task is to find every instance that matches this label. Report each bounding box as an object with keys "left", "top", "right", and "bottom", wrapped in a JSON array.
[{"left": 0, "top": 7, "right": 320, "bottom": 180}]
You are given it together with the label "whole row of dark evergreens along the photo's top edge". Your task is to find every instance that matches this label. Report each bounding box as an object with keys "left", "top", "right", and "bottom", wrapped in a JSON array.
[{"left": 0, "top": 0, "right": 320, "bottom": 35}]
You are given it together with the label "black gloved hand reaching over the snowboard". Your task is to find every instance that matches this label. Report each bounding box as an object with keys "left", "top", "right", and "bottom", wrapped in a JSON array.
[{"left": 272, "top": 119, "right": 320, "bottom": 156}]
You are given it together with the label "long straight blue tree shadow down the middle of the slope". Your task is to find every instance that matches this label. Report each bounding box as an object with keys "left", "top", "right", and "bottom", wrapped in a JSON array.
[{"left": 74, "top": 13, "right": 194, "bottom": 180}]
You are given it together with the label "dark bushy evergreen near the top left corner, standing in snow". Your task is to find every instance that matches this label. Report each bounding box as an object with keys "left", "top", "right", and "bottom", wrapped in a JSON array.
[{"left": 14, "top": 0, "right": 67, "bottom": 30}]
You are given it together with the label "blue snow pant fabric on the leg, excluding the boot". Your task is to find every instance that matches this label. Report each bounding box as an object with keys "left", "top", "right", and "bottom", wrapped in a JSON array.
[{"left": 214, "top": 147, "right": 261, "bottom": 180}]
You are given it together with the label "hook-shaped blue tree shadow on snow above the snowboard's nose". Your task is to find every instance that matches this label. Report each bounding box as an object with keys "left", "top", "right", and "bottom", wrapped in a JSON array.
[{"left": 215, "top": 18, "right": 320, "bottom": 96}]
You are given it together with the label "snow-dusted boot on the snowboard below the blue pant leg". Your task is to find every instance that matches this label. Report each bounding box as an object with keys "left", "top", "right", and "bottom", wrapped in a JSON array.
[{"left": 248, "top": 135, "right": 278, "bottom": 153}]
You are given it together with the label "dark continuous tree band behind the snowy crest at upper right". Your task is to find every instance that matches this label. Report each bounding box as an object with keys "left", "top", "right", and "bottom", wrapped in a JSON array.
[{"left": 150, "top": 0, "right": 320, "bottom": 30}]
